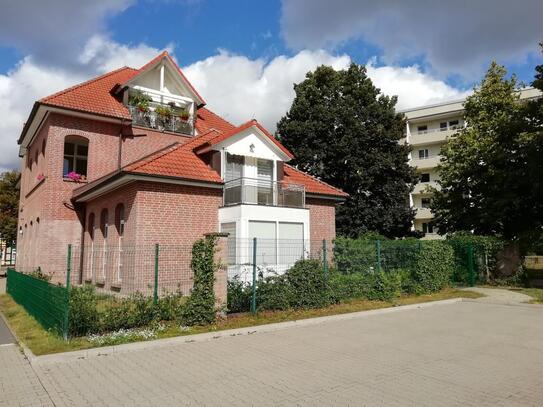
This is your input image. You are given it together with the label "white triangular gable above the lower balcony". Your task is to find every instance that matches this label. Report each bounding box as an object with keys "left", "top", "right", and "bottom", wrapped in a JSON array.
[{"left": 213, "top": 126, "right": 289, "bottom": 161}]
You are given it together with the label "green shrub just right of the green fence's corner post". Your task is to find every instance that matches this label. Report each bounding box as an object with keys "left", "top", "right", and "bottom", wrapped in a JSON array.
[{"left": 69, "top": 285, "right": 99, "bottom": 336}]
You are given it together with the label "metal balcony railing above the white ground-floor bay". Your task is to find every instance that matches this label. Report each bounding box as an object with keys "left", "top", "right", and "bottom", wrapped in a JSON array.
[{"left": 223, "top": 178, "right": 305, "bottom": 208}]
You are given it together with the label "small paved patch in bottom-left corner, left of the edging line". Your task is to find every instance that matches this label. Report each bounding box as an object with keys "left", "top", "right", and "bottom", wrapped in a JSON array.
[{"left": 0, "top": 344, "right": 53, "bottom": 407}]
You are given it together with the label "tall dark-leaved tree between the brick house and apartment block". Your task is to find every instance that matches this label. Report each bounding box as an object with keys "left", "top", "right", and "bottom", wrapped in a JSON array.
[{"left": 277, "top": 64, "right": 416, "bottom": 237}]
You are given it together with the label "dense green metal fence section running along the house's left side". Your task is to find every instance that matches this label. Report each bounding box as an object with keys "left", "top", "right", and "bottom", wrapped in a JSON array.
[{"left": 6, "top": 268, "right": 69, "bottom": 338}]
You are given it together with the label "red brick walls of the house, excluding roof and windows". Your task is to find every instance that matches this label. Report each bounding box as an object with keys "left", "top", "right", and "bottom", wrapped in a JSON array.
[{"left": 17, "top": 113, "right": 335, "bottom": 293}]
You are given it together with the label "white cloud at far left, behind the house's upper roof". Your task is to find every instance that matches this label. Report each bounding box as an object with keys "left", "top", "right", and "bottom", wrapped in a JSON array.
[{"left": 0, "top": 36, "right": 164, "bottom": 171}]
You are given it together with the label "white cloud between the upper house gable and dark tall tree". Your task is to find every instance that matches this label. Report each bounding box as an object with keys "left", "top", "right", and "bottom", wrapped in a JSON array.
[{"left": 183, "top": 51, "right": 351, "bottom": 131}]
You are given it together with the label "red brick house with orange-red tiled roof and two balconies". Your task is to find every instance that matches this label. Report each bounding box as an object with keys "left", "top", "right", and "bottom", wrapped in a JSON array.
[{"left": 17, "top": 52, "right": 346, "bottom": 288}]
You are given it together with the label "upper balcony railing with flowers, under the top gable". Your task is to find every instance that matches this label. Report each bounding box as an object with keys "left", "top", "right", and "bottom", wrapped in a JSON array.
[{"left": 128, "top": 103, "right": 194, "bottom": 136}]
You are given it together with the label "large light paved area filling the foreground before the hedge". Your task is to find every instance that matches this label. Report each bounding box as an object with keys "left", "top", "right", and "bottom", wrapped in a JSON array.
[{"left": 0, "top": 302, "right": 543, "bottom": 407}]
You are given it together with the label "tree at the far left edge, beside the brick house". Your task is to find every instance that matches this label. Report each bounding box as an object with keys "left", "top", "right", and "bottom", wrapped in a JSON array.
[{"left": 0, "top": 171, "right": 19, "bottom": 242}]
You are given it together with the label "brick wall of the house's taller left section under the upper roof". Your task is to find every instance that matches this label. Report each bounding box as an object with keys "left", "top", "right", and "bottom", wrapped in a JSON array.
[{"left": 17, "top": 113, "right": 196, "bottom": 281}]
